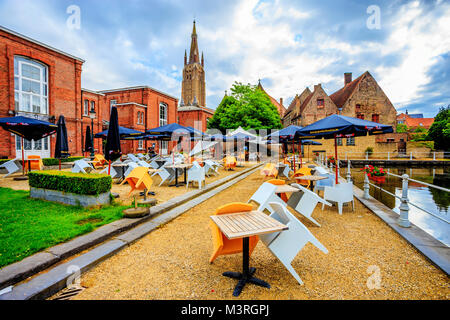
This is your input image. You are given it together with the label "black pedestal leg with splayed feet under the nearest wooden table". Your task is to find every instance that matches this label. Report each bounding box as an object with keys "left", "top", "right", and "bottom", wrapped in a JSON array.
[{"left": 222, "top": 237, "right": 270, "bottom": 297}]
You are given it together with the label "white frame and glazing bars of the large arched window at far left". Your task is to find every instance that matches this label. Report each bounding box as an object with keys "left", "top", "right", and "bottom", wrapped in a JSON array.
[{"left": 14, "top": 56, "right": 49, "bottom": 115}]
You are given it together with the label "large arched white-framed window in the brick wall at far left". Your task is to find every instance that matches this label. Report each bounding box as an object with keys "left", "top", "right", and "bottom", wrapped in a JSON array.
[{"left": 14, "top": 56, "right": 48, "bottom": 114}]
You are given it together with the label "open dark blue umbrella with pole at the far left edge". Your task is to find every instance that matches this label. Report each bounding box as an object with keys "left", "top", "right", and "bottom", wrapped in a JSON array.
[{"left": 0, "top": 116, "right": 58, "bottom": 174}]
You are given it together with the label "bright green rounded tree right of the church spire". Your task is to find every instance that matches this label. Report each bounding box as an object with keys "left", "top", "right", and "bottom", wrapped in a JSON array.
[{"left": 208, "top": 82, "right": 282, "bottom": 133}]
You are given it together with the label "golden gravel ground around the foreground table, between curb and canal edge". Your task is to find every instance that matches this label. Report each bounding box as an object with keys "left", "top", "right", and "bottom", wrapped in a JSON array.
[{"left": 65, "top": 171, "right": 450, "bottom": 300}]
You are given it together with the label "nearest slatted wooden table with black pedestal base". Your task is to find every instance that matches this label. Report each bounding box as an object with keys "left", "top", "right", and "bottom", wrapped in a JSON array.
[{"left": 210, "top": 211, "right": 288, "bottom": 297}]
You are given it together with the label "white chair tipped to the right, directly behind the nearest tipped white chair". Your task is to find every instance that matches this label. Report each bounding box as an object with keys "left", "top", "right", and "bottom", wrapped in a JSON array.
[{"left": 287, "top": 183, "right": 331, "bottom": 227}]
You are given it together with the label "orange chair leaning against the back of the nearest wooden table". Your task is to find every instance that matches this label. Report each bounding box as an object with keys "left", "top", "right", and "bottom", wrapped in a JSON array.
[{"left": 209, "top": 202, "right": 259, "bottom": 263}]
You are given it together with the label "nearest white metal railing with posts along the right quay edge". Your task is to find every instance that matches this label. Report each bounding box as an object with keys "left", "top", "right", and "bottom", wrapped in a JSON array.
[{"left": 360, "top": 166, "right": 450, "bottom": 228}]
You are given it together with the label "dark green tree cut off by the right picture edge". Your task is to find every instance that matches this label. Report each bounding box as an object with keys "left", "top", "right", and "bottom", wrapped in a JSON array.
[{"left": 427, "top": 105, "right": 450, "bottom": 151}]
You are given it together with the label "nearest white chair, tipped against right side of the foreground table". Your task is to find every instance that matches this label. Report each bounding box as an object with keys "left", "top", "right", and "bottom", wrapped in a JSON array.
[{"left": 259, "top": 203, "right": 328, "bottom": 285}]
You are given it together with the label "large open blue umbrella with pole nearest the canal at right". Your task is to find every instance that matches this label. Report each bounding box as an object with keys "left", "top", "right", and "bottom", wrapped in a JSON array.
[{"left": 295, "top": 114, "right": 394, "bottom": 184}]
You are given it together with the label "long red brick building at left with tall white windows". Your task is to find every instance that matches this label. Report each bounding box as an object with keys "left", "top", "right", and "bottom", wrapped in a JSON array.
[{"left": 0, "top": 27, "right": 178, "bottom": 158}]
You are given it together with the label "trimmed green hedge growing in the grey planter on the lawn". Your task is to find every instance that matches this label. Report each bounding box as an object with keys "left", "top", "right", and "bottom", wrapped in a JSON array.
[{"left": 28, "top": 170, "right": 112, "bottom": 196}]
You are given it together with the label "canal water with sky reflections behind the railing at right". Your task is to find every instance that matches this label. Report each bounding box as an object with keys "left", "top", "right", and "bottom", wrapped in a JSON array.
[{"left": 340, "top": 166, "right": 450, "bottom": 246}]
